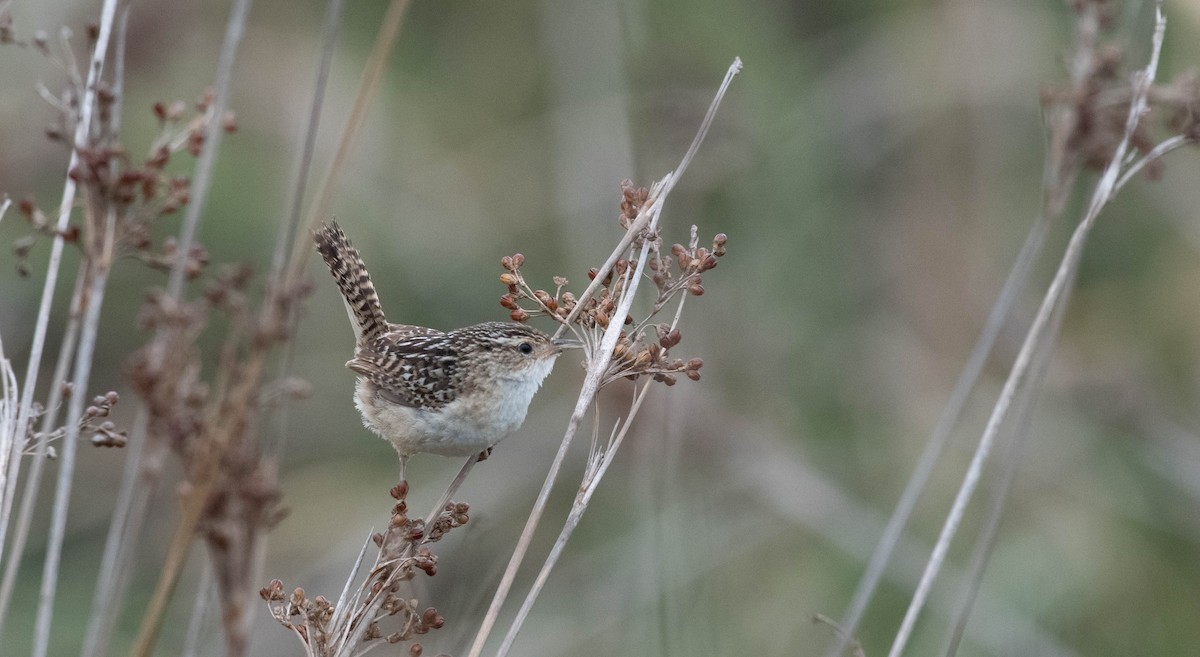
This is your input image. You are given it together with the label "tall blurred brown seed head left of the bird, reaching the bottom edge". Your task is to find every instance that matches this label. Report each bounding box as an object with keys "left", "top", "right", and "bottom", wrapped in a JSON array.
[{"left": 127, "top": 258, "right": 311, "bottom": 655}]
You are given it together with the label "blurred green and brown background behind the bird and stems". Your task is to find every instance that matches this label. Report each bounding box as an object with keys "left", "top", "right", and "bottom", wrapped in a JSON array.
[{"left": 0, "top": 0, "right": 1200, "bottom": 657}]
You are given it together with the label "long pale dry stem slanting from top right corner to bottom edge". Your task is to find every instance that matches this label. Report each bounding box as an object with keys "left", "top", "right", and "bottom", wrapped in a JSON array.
[{"left": 888, "top": 6, "right": 1166, "bottom": 657}]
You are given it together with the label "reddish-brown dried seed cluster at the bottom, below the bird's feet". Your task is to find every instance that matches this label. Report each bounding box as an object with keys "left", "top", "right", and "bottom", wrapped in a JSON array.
[{"left": 259, "top": 482, "right": 460, "bottom": 657}]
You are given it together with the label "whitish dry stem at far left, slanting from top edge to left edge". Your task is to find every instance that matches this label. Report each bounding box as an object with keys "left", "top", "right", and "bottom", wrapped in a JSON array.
[{"left": 0, "top": 0, "right": 116, "bottom": 570}]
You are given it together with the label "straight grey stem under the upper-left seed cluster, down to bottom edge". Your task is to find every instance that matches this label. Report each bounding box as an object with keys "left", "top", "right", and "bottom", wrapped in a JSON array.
[{"left": 32, "top": 209, "right": 116, "bottom": 657}]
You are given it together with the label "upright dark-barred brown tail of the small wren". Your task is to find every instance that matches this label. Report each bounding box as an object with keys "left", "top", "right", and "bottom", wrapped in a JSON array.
[{"left": 312, "top": 221, "right": 388, "bottom": 345}]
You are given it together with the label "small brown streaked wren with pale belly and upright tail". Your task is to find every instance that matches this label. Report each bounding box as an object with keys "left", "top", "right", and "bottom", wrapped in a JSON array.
[{"left": 313, "top": 221, "right": 574, "bottom": 487}]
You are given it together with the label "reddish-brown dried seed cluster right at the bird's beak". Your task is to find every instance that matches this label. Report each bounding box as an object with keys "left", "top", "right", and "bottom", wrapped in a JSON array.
[{"left": 500, "top": 180, "right": 728, "bottom": 386}]
